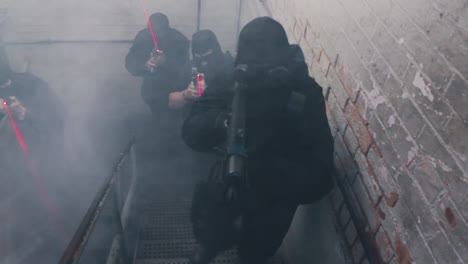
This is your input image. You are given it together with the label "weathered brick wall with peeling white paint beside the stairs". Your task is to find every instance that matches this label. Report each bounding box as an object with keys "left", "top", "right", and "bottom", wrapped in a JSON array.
[{"left": 247, "top": 0, "right": 468, "bottom": 264}]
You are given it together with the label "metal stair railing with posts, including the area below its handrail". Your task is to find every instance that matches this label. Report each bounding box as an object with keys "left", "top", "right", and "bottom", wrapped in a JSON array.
[{"left": 59, "top": 138, "right": 137, "bottom": 264}]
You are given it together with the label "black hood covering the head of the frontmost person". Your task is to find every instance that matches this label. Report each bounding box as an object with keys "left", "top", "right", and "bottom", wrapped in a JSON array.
[{"left": 236, "top": 17, "right": 289, "bottom": 65}]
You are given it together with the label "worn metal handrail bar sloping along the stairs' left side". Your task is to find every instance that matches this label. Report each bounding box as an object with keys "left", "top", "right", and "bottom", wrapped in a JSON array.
[{"left": 59, "top": 137, "right": 135, "bottom": 264}]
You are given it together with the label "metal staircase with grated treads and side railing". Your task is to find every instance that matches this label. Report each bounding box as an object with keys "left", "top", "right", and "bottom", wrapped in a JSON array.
[{"left": 60, "top": 138, "right": 284, "bottom": 264}]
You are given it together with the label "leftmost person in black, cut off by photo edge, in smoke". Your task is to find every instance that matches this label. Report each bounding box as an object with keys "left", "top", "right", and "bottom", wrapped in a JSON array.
[{"left": 0, "top": 67, "right": 68, "bottom": 256}]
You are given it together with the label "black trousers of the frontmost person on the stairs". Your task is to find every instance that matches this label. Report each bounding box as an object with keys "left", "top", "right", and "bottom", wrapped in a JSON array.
[{"left": 191, "top": 175, "right": 298, "bottom": 264}]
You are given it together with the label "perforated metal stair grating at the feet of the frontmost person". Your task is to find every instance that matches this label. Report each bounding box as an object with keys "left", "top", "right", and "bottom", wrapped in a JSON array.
[{"left": 134, "top": 188, "right": 284, "bottom": 264}]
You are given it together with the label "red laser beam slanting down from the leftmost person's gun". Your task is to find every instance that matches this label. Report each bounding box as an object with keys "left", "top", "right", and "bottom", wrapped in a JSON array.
[{"left": 3, "top": 101, "right": 57, "bottom": 219}]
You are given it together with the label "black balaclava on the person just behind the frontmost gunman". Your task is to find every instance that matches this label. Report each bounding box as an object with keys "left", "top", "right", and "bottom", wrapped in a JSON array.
[{"left": 192, "top": 30, "right": 223, "bottom": 78}]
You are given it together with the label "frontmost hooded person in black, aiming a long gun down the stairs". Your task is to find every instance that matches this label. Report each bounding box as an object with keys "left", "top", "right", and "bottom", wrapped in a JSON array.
[{"left": 183, "top": 17, "right": 333, "bottom": 264}]
